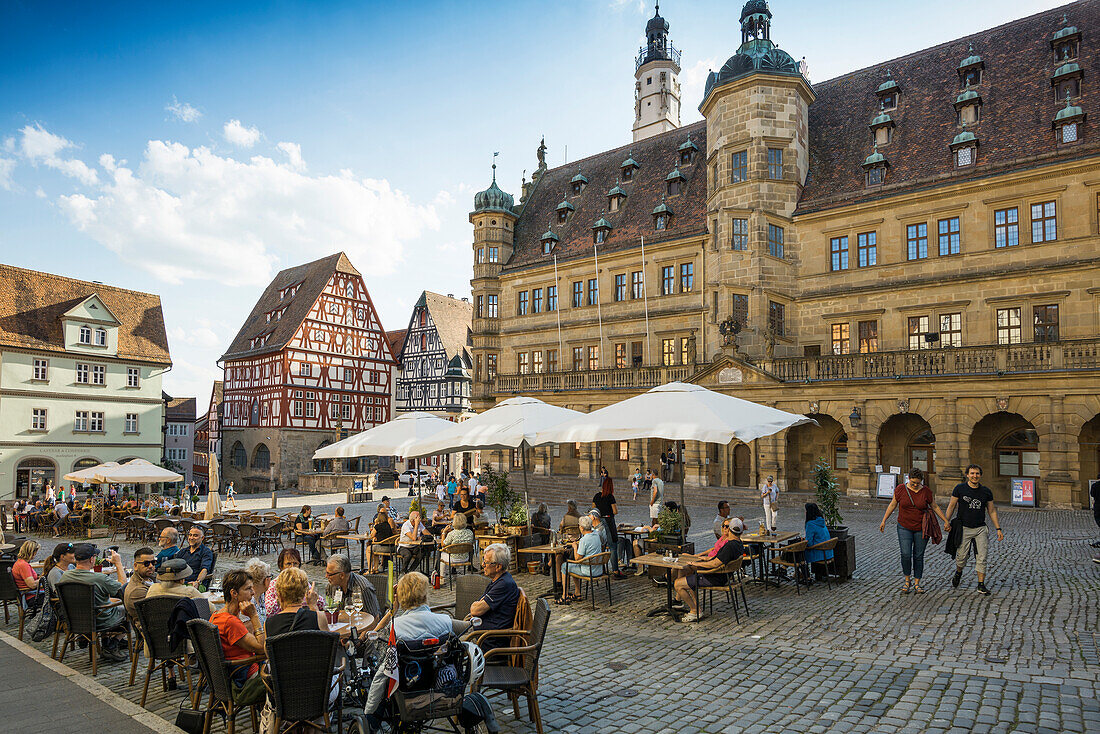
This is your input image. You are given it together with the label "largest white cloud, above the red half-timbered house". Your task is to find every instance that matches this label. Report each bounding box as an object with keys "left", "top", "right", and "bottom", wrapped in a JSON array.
[{"left": 51, "top": 136, "right": 439, "bottom": 286}]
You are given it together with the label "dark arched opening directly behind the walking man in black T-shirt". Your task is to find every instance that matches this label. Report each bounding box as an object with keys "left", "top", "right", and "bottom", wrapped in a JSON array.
[{"left": 969, "top": 412, "right": 1043, "bottom": 503}]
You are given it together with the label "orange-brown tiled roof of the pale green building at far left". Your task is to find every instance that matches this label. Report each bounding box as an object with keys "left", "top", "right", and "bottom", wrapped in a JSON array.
[{"left": 0, "top": 265, "right": 172, "bottom": 365}]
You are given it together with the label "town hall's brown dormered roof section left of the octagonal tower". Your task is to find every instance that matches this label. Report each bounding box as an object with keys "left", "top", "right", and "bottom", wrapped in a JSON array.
[{"left": 503, "top": 120, "right": 706, "bottom": 271}]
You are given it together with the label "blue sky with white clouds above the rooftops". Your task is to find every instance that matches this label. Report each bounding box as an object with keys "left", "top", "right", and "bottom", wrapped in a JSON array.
[{"left": 0, "top": 0, "right": 1073, "bottom": 404}]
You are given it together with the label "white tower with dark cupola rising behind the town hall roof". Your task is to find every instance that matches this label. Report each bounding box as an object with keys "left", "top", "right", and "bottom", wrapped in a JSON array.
[{"left": 634, "top": 3, "right": 680, "bottom": 142}]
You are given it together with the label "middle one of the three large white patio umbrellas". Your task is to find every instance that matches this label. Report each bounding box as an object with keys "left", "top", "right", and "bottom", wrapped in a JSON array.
[{"left": 408, "top": 397, "right": 585, "bottom": 521}]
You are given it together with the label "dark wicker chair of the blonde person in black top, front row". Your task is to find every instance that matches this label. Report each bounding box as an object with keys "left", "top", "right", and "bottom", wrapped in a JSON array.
[{"left": 262, "top": 629, "right": 347, "bottom": 734}]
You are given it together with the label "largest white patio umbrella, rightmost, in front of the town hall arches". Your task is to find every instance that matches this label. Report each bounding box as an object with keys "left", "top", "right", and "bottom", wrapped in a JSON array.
[{"left": 532, "top": 382, "right": 817, "bottom": 504}]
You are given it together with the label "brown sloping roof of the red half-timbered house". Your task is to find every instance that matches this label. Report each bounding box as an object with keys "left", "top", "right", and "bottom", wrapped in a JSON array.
[{"left": 218, "top": 252, "right": 360, "bottom": 362}]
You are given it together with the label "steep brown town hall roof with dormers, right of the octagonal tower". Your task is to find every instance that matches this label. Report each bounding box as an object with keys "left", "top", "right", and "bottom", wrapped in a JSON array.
[{"left": 798, "top": 0, "right": 1100, "bottom": 213}]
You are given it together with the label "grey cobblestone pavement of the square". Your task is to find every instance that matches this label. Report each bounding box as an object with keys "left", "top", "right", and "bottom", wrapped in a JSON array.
[{"left": 7, "top": 495, "right": 1100, "bottom": 734}]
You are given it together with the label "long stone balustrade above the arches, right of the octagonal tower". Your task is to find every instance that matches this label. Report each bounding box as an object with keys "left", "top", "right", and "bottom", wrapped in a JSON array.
[{"left": 760, "top": 339, "right": 1100, "bottom": 382}]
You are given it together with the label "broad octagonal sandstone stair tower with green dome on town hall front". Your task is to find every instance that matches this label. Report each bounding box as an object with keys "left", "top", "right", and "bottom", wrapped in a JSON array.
[{"left": 700, "top": 0, "right": 814, "bottom": 357}]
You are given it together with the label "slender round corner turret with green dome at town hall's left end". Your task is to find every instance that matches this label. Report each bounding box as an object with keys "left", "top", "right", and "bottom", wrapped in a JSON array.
[{"left": 470, "top": 163, "right": 518, "bottom": 413}]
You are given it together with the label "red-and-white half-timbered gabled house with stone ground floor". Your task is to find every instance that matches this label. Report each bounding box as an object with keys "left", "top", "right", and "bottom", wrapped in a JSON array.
[{"left": 221, "top": 253, "right": 394, "bottom": 490}]
